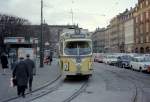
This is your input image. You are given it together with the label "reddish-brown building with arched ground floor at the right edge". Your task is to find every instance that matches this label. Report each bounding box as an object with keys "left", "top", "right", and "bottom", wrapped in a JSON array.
[{"left": 134, "top": 0, "right": 150, "bottom": 53}]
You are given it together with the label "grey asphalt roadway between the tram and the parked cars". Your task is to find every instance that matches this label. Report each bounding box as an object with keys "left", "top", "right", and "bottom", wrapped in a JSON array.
[{"left": 72, "top": 63, "right": 150, "bottom": 102}]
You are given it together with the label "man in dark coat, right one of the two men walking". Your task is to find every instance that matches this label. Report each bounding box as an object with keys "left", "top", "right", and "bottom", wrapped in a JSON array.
[{"left": 25, "top": 54, "right": 35, "bottom": 92}]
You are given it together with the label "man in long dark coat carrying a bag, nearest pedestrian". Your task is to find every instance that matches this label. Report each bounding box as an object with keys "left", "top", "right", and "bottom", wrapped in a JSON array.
[{"left": 12, "top": 57, "right": 29, "bottom": 98}]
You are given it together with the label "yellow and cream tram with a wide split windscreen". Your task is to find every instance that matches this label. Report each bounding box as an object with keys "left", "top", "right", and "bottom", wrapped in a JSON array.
[{"left": 59, "top": 30, "right": 93, "bottom": 76}]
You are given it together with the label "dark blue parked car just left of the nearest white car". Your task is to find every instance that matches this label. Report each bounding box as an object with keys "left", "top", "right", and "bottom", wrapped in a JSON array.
[{"left": 117, "top": 55, "right": 132, "bottom": 68}]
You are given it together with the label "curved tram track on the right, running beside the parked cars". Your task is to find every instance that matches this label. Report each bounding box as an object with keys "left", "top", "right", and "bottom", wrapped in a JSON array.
[{"left": 102, "top": 63, "right": 150, "bottom": 102}]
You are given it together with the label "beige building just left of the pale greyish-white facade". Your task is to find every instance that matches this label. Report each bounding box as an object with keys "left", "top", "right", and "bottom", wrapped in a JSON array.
[{"left": 109, "top": 11, "right": 127, "bottom": 53}]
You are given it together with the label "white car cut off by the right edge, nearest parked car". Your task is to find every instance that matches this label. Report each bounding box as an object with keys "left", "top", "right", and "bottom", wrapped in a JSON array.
[{"left": 130, "top": 57, "right": 150, "bottom": 72}]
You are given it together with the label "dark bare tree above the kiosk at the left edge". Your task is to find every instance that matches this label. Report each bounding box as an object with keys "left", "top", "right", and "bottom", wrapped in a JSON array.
[{"left": 0, "top": 14, "right": 30, "bottom": 53}]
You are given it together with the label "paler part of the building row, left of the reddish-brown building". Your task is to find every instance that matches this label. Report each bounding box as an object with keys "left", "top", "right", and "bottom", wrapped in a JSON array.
[{"left": 94, "top": 8, "right": 134, "bottom": 53}]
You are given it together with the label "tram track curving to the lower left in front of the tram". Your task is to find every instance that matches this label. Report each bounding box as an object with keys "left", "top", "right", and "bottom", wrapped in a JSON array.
[{"left": 2, "top": 76, "right": 89, "bottom": 102}]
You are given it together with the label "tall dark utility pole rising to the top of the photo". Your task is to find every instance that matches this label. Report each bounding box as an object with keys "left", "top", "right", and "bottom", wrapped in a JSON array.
[{"left": 40, "top": 0, "right": 44, "bottom": 68}]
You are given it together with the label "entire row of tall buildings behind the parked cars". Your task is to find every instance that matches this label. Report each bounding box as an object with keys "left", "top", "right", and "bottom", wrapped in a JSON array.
[{"left": 92, "top": 0, "right": 150, "bottom": 53}]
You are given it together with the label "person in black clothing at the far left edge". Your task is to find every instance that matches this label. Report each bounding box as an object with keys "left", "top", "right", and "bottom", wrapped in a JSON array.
[{"left": 0, "top": 53, "right": 8, "bottom": 75}]
